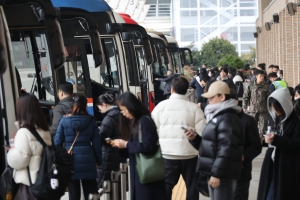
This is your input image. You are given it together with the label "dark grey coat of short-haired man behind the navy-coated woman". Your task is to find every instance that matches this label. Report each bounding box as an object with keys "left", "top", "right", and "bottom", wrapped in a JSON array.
[{"left": 50, "top": 96, "right": 73, "bottom": 137}]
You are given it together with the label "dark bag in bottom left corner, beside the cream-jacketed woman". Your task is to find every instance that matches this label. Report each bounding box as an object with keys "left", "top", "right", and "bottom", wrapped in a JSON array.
[{"left": 0, "top": 166, "right": 19, "bottom": 199}]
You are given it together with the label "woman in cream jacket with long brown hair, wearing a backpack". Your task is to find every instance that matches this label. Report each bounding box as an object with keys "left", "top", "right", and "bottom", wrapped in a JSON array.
[{"left": 7, "top": 94, "right": 52, "bottom": 200}]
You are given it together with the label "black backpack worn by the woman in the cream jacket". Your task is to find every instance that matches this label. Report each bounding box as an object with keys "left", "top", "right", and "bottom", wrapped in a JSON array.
[{"left": 27, "top": 128, "right": 74, "bottom": 200}]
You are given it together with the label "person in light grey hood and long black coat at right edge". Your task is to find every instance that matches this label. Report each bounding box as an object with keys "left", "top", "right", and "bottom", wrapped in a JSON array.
[{"left": 257, "top": 88, "right": 300, "bottom": 200}]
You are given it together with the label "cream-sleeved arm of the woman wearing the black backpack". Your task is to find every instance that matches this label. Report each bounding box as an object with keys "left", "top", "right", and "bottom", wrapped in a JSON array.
[{"left": 7, "top": 128, "right": 32, "bottom": 170}]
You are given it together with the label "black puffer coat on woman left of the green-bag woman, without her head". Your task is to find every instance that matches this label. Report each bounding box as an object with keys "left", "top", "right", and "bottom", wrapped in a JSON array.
[{"left": 97, "top": 107, "right": 126, "bottom": 185}]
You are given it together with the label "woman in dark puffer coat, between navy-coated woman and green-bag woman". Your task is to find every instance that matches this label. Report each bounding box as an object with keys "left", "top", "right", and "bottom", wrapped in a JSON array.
[{"left": 96, "top": 93, "right": 126, "bottom": 188}]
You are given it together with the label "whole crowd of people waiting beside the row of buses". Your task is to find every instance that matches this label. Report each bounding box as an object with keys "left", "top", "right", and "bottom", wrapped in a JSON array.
[{"left": 3, "top": 63, "right": 300, "bottom": 200}]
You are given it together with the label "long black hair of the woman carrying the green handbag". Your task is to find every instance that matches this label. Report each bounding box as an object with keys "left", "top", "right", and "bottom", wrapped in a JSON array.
[{"left": 117, "top": 92, "right": 151, "bottom": 139}]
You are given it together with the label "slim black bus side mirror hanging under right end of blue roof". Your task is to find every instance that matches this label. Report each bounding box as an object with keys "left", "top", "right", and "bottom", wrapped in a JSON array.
[{"left": 90, "top": 29, "right": 103, "bottom": 67}]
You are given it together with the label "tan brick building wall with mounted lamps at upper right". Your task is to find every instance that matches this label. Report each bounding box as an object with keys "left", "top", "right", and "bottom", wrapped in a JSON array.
[{"left": 255, "top": 0, "right": 300, "bottom": 87}]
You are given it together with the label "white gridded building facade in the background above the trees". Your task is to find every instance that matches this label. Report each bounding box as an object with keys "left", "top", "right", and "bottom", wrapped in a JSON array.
[{"left": 172, "top": 0, "right": 257, "bottom": 54}]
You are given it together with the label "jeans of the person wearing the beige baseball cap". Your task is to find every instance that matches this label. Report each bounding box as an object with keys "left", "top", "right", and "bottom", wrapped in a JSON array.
[{"left": 207, "top": 176, "right": 237, "bottom": 200}]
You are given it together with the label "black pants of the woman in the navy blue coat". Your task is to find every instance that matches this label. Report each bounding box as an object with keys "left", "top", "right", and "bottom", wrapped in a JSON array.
[{"left": 68, "top": 179, "right": 98, "bottom": 200}]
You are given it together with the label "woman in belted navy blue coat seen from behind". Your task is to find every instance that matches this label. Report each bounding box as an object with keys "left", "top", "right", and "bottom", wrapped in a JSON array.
[{"left": 54, "top": 95, "right": 101, "bottom": 200}]
